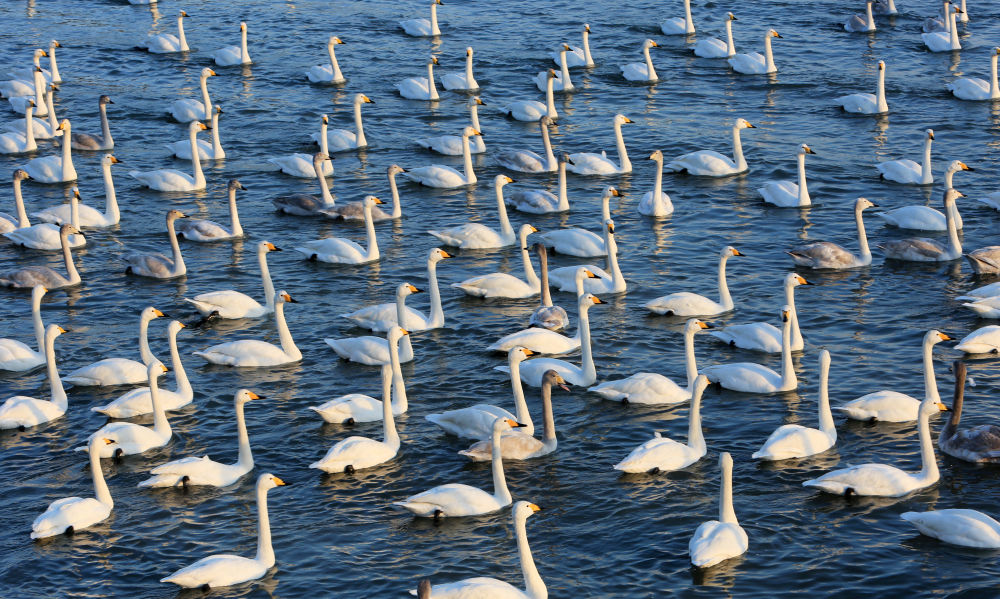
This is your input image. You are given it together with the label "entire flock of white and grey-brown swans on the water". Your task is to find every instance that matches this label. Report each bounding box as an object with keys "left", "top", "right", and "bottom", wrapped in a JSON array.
[{"left": 0, "top": 0, "right": 1000, "bottom": 599}]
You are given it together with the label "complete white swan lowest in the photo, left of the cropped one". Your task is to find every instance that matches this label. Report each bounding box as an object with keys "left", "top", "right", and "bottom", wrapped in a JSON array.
[{"left": 160, "top": 473, "right": 287, "bottom": 589}]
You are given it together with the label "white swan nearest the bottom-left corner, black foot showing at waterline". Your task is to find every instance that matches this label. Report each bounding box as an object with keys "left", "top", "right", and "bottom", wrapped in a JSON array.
[{"left": 31, "top": 438, "right": 115, "bottom": 539}]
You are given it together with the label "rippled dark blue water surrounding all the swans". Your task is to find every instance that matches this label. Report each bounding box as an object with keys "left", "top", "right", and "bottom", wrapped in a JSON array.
[{"left": 0, "top": 0, "right": 1000, "bottom": 597}]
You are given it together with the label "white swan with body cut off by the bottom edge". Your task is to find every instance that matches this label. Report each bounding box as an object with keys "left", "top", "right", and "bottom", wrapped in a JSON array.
[{"left": 411, "top": 501, "right": 548, "bottom": 599}]
